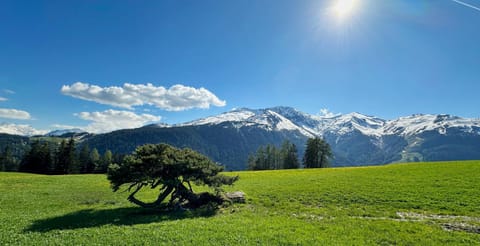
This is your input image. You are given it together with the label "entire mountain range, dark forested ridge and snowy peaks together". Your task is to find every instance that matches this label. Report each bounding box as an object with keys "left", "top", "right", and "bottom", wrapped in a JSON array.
[{"left": 0, "top": 107, "right": 480, "bottom": 170}]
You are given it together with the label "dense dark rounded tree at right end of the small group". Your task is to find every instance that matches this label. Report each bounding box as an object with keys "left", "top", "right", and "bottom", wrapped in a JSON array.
[{"left": 303, "top": 137, "right": 333, "bottom": 168}]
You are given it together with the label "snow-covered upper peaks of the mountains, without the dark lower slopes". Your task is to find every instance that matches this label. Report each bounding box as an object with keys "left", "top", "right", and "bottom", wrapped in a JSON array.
[{"left": 183, "top": 107, "right": 480, "bottom": 137}]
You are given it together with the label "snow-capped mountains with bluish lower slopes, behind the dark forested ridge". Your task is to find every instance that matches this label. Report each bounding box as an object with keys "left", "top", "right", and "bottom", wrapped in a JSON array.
[{"left": 168, "top": 107, "right": 480, "bottom": 165}]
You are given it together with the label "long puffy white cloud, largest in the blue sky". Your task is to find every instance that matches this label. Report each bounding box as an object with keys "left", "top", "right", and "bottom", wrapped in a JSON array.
[{"left": 61, "top": 82, "right": 226, "bottom": 111}]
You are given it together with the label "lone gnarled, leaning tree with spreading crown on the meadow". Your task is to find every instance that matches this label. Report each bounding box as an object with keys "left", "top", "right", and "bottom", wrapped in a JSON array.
[{"left": 108, "top": 144, "right": 238, "bottom": 208}]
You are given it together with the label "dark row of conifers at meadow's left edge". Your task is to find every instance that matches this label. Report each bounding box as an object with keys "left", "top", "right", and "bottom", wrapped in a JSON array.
[{"left": 0, "top": 138, "right": 123, "bottom": 174}]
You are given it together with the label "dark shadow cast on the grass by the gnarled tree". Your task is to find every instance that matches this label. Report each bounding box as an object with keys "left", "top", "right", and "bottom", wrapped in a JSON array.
[{"left": 24, "top": 207, "right": 217, "bottom": 232}]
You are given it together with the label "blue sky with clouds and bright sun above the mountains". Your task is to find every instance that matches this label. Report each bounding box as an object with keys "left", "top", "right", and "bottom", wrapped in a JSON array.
[{"left": 0, "top": 0, "right": 480, "bottom": 132}]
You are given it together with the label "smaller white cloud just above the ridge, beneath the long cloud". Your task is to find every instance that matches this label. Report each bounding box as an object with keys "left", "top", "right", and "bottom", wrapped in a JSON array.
[{"left": 75, "top": 109, "right": 161, "bottom": 133}]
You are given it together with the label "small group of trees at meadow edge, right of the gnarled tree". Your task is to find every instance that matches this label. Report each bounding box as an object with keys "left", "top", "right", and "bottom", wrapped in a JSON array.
[{"left": 247, "top": 137, "right": 333, "bottom": 170}]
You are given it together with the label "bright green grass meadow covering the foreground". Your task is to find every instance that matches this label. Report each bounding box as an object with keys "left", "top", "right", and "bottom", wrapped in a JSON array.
[{"left": 0, "top": 161, "right": 480, "bottom": 245}]
